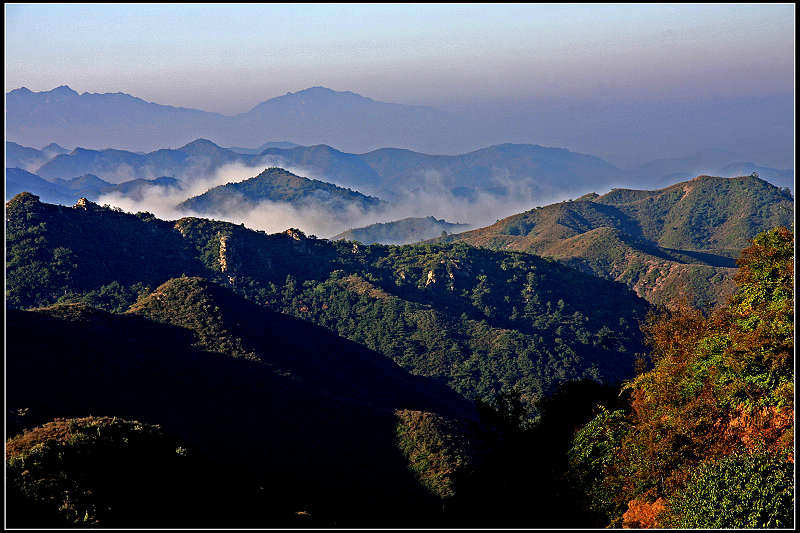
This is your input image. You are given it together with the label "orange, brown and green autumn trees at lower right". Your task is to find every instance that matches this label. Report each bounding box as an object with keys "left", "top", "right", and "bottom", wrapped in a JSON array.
[{"left": 571, "top": 228, "right": 794, "bottom": 527}]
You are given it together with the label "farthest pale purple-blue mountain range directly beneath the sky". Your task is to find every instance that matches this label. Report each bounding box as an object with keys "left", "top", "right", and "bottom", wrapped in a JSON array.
[{"left": 6, "top": 86, "right": 793, "bottom": 171}]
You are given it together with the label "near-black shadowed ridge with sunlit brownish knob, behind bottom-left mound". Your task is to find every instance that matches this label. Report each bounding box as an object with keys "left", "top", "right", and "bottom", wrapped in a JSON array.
[{"left": 6, "top": 278, "right": 472, "bottom": 526}]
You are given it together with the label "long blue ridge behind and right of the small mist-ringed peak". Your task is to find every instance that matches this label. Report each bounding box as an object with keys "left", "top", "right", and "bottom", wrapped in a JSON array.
[{"left": 262, "top": 144, "right": 624, "bottom": 200}]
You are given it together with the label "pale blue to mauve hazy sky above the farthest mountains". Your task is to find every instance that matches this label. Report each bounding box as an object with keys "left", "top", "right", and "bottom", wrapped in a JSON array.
[{"left": 5, "top": 4, "right": 794, "bottom": 114}]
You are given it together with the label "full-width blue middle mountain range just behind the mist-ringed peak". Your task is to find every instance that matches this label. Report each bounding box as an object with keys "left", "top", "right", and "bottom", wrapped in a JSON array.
[{"left": 6, "top": 135, "right": 794, "bottom": 214}]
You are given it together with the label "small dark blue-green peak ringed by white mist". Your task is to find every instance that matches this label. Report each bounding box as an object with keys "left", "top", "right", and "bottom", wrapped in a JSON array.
[{"left": 177, "top": 168, "right": 386, "bottom": 216}]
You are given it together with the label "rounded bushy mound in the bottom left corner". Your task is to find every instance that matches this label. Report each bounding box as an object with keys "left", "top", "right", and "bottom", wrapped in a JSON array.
[{"left": 6, "top": 417, "right": 276, "bottom": 528}]
